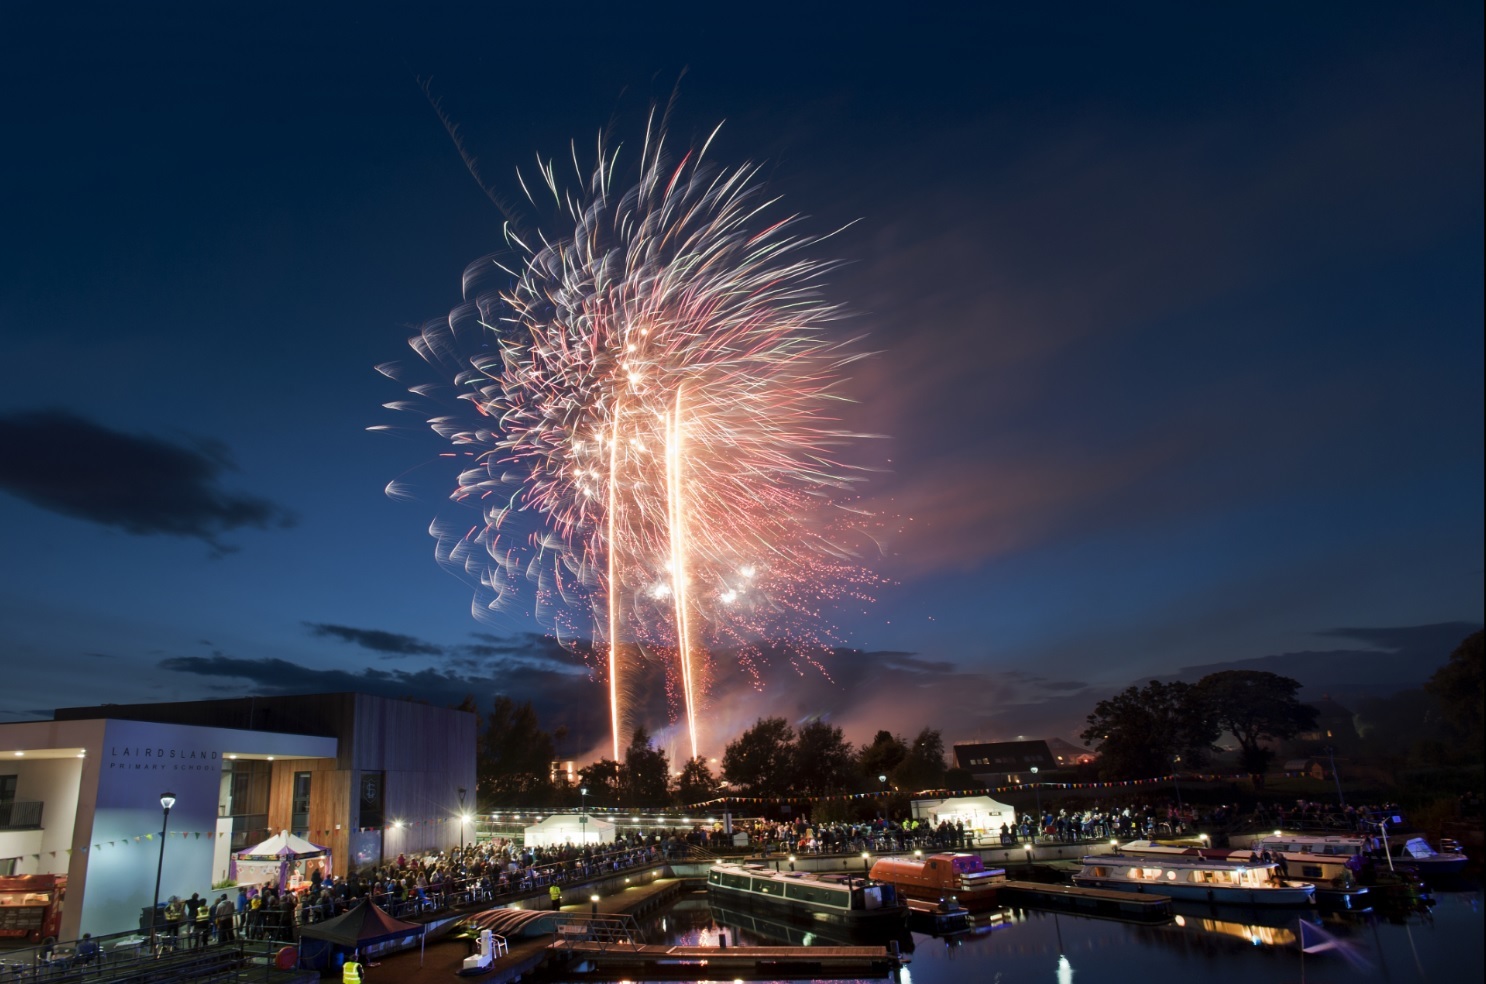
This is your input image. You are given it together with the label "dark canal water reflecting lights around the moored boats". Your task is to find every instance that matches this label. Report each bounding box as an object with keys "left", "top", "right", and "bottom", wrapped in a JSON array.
[{"left": 588, "top": 883, "right": 1486, "bottom": 984}]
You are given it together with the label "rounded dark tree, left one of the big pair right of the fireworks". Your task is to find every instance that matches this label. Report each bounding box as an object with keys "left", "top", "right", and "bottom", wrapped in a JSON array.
[{"left": 1079, "top": 679, "right": 1219, "bottom": 779}]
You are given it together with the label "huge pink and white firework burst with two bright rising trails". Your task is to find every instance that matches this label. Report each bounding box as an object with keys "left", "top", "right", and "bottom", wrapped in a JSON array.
[{"left": 377, "top": 117, "right": 872, "bottom": 760}]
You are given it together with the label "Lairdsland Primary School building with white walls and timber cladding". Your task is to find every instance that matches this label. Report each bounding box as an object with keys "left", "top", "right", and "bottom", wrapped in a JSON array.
[{"left": 0, "top": 694, "right": 476, "bottom": 939}]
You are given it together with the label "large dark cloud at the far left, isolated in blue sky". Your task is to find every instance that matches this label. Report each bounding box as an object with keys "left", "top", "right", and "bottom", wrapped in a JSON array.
[{"left": 0, "top": 410, "right": 294, "bottom": 553}]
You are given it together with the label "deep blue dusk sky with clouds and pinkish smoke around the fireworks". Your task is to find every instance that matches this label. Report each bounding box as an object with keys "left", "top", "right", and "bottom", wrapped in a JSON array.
[{"left": 0, "top": 0, "right": 1483, "bottom": 758}]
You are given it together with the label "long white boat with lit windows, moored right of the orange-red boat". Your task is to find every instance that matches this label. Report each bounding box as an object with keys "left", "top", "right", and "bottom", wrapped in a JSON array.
[{"left": 1073, "top": 855, "right": 1315, "bottom": 905}]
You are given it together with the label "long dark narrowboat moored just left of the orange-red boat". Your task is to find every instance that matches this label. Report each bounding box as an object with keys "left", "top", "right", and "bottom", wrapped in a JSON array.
[{"left": 707, "top": 862, "right": 908, "bottom": 928}]
